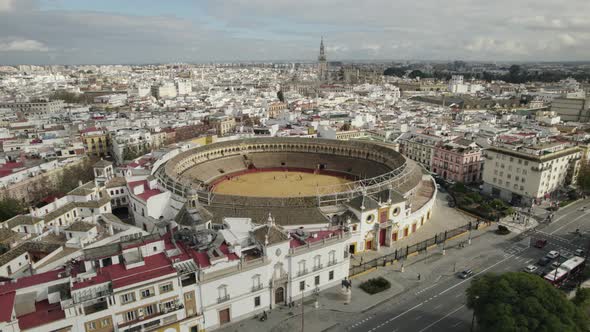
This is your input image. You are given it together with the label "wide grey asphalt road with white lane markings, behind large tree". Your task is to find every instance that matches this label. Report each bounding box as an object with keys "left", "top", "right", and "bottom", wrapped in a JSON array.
[{"left": 342, "top": 200, "right": 590, "bottom": 332}]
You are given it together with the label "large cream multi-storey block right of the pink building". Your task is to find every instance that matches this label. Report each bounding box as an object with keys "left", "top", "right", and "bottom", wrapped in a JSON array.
[{"left": 483, "top": 143, "right": 582, "bottom": 204}]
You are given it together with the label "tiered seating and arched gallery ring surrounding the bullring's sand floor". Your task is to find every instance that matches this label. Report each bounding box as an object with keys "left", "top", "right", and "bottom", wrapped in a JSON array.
[{"left": 155, "top": 138, "right": 422, "bottom": 206}]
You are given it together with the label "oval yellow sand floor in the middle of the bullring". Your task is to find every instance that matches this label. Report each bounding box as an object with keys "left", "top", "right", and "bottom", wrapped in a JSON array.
[{"left": 213, "top": 171, "right": 350, "bottom": 197}]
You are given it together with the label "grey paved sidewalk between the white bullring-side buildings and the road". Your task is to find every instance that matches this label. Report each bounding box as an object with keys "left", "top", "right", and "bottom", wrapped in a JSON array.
[{"left": 218, "top": 227, "right": 494, "bottom": 332}]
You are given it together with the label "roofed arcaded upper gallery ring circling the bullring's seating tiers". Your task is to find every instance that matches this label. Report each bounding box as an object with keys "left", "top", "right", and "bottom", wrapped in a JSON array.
[{"left": 155, "top": 138, "right": 422, "bottom": 206}]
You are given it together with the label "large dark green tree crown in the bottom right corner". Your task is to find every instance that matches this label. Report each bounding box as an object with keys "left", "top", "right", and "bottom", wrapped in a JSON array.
[{"left": 467, "top": 272, "right": 589, "bottom": 332}]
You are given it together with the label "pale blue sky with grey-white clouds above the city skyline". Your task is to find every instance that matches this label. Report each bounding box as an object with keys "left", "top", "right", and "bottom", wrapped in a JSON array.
[{"left": 0, "top": 0, "right": 590, "bottom": 64}]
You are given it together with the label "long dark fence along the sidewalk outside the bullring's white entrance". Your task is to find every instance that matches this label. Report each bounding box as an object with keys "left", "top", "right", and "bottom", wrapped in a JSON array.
[{"left": 348, "top": 221, "right": 484, "bottom": 278}]
